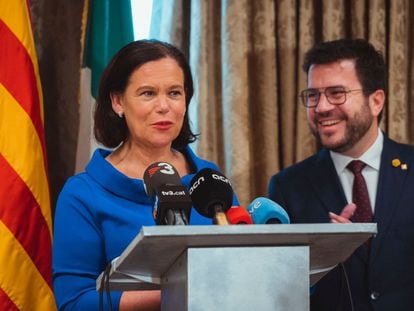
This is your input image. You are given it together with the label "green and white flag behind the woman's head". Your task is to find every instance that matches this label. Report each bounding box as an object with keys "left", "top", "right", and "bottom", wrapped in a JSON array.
[{"left": 76, "top": 0, "right": 134, "bottom": 172}]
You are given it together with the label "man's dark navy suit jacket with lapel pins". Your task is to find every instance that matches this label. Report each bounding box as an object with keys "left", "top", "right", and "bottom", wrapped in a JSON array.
[{"left": 269, "top": 135, "right": 414, "bottom": 311}]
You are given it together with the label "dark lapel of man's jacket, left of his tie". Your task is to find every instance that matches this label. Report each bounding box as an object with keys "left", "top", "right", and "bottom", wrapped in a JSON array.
[{"left": 308, "top": 149, "right": 346, "bottom": 214}]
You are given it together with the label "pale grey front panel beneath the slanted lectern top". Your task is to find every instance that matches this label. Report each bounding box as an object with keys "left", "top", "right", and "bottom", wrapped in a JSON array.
[{"left": 161, "top": 246, "right": 309, "bottom": 311}]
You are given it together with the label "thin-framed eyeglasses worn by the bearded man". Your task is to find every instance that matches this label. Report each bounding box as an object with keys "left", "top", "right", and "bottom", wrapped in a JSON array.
[{"left": 300, "top": 86, "right": 362, "bottom": 108}]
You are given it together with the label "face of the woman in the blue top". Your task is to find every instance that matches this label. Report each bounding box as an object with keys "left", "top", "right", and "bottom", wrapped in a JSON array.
[{"left": 111, "top": 58, "right": 186, "bottom": 148}]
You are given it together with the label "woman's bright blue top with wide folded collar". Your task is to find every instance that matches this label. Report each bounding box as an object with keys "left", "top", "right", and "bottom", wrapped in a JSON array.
[{"left": 53, "top": 147, "right": 238, "bottom": 310}]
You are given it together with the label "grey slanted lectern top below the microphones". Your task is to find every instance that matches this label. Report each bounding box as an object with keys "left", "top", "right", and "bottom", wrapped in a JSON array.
[{"left": 97, "top": 223, "right": 377, "bottom": 290}]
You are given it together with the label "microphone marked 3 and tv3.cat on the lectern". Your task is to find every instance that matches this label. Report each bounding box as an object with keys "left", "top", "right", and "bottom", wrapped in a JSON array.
[{"left": 144, "top": 162, "right": 192, "bottom": 225}]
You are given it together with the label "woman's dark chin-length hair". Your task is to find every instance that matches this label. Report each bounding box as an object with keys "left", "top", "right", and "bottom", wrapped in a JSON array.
[{"left": 94, "top": 40, "right": 197, "bottom": 149}]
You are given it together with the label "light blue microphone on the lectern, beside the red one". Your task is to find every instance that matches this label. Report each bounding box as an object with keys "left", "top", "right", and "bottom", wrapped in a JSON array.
[{"left": 247, "top": 197, "right": 290, "bottom": 224}]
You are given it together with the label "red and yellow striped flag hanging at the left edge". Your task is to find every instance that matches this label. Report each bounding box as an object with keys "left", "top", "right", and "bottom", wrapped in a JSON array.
[{"left": 0, "top": 0, "right": 56, "bottom": 310}]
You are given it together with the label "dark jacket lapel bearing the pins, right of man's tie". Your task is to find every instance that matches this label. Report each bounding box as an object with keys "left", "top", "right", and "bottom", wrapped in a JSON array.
[{"left": 371, "top": 135, "right": 409, "bottom": 260}]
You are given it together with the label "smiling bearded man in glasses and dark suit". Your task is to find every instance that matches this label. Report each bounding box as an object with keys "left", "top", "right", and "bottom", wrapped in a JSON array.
[{"left": 269, "top": 39, "right": 414, "bottom": 311}]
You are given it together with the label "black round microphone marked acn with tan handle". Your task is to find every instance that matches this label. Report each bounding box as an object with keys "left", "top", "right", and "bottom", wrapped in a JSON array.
[{"left": 189, "top": 168, "right": 233, "bottom": 225}]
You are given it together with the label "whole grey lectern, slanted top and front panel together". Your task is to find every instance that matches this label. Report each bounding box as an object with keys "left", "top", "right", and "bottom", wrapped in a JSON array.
[{"left": 96, "top": 223, "right": 377, "bottom": 311}]
